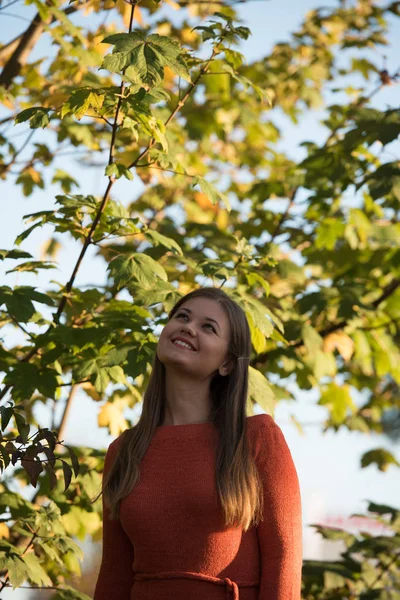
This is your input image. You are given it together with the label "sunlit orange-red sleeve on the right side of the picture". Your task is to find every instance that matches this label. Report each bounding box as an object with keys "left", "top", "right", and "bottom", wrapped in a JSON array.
[{"left": 255, "top": 415, "right": 302, "bottom": 600}]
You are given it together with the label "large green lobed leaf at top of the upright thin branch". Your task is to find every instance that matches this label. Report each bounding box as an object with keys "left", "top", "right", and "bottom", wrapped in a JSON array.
[{"left": 102, "top": 31, "right": 190, "bottom": 87}]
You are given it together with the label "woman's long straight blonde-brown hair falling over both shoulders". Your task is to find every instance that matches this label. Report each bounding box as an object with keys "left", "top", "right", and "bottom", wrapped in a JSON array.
[{"left": 95, "top": 287, "right": 263, "bottom": 531}]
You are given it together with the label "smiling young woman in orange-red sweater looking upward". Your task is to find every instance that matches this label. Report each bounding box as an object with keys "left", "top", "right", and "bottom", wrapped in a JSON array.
[{"left": 94, "top": 288, "right": 302, "bottom": 600}]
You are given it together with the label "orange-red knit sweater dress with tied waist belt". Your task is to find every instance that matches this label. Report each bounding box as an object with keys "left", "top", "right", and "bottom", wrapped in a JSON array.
[{"left": 94, "top": 414, "right": 302, "bottom": 600}]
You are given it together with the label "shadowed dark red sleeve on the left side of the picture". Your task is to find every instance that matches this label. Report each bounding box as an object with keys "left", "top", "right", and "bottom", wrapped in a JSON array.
[{"left": 93, "top": 439, "right": 134, "bottom": 600}]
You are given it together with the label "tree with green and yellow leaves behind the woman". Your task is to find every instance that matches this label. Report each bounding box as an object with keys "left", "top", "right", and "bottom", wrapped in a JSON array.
[{"left": 0, "top": 0, "right": 400, "bottom": 599}]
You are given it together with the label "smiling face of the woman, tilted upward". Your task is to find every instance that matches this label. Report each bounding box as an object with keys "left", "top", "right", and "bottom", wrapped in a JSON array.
[{"left": 157, "top": 297, "right": 230, "bottom": 380}]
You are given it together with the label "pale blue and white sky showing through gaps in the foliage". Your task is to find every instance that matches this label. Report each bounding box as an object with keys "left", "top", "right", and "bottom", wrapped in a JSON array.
[{"left": 0, "top": 0, "right": 400, "bottom": 600}]
